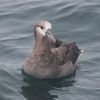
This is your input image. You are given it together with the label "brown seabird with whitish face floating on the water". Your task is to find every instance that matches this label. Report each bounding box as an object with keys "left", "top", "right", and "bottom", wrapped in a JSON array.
[{"left": 23, "top": 21, "right": 81, "bottom": 79}]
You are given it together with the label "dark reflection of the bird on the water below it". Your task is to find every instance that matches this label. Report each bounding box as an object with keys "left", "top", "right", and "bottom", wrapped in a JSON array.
[{"left": 21, "top": 73, "right": 75, "bottom": 100}]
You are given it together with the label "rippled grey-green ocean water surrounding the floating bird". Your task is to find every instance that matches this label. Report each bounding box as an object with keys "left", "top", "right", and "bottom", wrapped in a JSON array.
[{"left": 0, "top": 0, "right": 100, "bottom": 100}]
